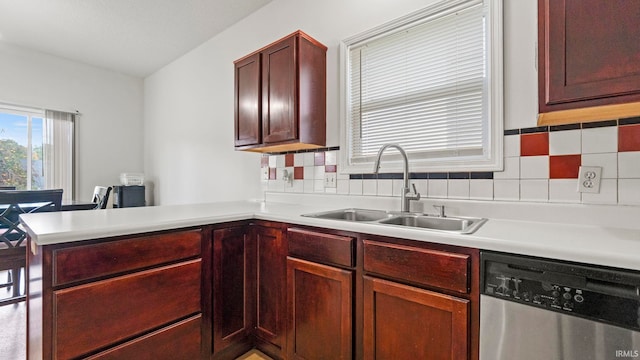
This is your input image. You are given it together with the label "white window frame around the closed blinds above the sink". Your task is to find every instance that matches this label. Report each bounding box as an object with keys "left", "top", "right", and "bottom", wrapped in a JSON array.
[{"left": 340, "top": 0, "right": 504, "bottom": 174}]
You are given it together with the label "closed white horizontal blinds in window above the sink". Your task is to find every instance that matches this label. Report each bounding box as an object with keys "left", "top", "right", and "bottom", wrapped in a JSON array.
[{"left": 350, "top": 3, "right": 486, "bottom": 163}]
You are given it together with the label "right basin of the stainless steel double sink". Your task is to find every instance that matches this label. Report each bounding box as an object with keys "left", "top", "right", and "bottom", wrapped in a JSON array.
[{"left": 379, "top": 214, "right": 487, "bottom": 234}]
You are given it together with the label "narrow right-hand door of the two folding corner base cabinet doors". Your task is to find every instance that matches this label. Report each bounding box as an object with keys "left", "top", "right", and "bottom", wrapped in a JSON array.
[{"left": 254, "top": 226, "right": 286, "bottom": 356}]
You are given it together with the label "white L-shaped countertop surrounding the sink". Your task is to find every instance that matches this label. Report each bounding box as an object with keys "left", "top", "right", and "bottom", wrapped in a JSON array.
[{"left": 20, "top": 201, "right": 640, "bottom": 270}]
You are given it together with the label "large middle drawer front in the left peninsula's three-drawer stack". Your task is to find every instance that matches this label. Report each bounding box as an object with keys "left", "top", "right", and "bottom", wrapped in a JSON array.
[{"left": 53, "top": 260, "right": 201, "bottom": 359}]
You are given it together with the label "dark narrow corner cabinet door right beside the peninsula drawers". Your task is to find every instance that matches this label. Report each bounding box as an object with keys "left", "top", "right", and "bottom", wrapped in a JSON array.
[{"left": 213, "top": 226, "right": 254, "bottom": 355}]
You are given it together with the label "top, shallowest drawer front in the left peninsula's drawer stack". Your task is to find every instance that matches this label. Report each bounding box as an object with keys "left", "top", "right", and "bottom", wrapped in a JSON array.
[{"left": 53, "top": 230, "right": 202, "bottom": 286}]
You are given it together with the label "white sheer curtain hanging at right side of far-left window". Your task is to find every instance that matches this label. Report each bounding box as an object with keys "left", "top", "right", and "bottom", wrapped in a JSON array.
[{"left": 42, "top": 110, "right": 75, "bottom": 201}]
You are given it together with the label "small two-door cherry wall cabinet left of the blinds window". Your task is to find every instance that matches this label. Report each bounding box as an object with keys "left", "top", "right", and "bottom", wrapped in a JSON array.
[{"left": 234, "top": 31, "right": 327, "bottom": 152}]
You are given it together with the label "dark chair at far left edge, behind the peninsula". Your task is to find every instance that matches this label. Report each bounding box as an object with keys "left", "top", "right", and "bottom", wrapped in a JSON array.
[{"left": 0, "top": 189, "right": 62, "bottom": 305}]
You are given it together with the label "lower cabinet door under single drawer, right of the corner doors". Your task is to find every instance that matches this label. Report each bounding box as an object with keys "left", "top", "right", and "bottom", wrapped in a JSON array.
[{"left": 287, "top": 257, "right": 353, "bottom": 360}]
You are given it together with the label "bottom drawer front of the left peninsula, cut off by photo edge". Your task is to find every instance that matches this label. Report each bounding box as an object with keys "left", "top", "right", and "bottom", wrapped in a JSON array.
[{"left": 87, "top": 315, "right": 202, "bottom": 360}]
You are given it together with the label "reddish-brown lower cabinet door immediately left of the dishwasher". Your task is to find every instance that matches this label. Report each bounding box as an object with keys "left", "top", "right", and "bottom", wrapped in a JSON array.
[{"left": 363, "top": 276, "right": 469, "bottom": 360}]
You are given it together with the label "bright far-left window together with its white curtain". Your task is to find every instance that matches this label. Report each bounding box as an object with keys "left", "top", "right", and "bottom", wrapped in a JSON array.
[{"left": 0, "top": 105, "right": 75, "bottom": 200}]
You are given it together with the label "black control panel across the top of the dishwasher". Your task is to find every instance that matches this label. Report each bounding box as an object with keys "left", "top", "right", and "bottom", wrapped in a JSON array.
[{"left": 481, "top": 252, "right": 640, "bottom": 331}]
